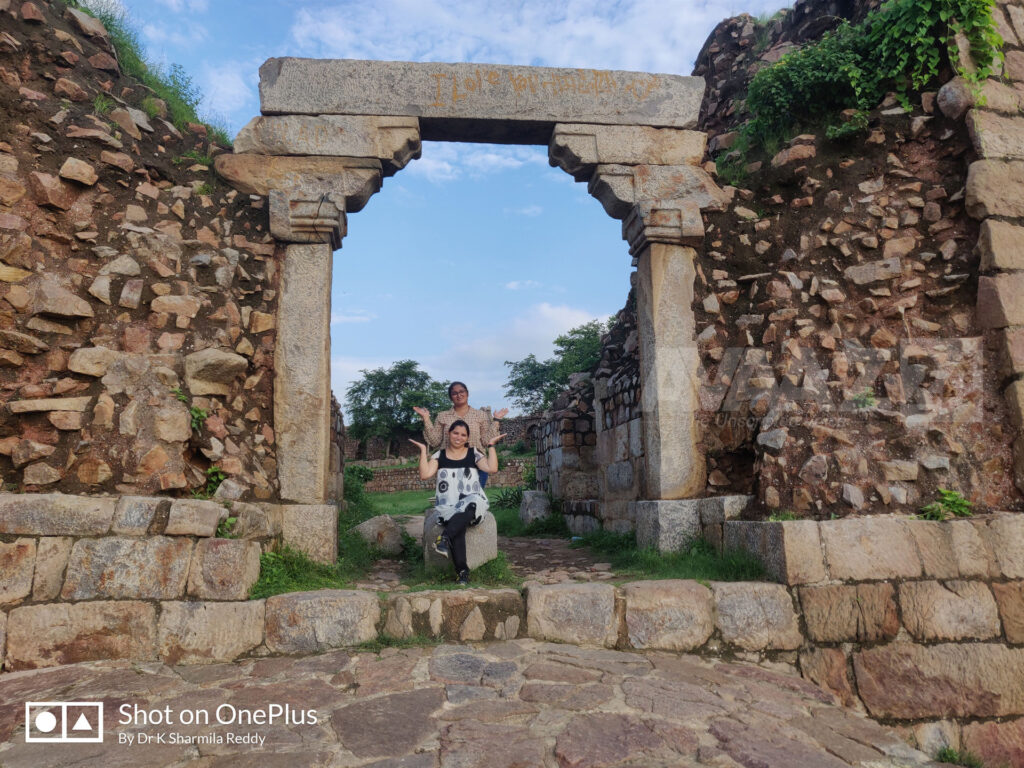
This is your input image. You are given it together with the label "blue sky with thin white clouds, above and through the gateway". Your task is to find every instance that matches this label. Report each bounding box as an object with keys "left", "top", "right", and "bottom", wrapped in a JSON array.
[{"left": 105, "top": 0, "right": 783, "bottom": 411}]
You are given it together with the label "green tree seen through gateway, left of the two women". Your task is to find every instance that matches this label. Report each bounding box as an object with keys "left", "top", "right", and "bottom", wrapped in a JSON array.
[{"left": 345, "top": 360, "right": 451, "bottom": 450}]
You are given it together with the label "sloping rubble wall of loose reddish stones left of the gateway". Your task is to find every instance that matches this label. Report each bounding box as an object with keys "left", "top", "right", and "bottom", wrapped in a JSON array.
[{"left": 0, "top": 0, "right": 281, "bottom": 500}]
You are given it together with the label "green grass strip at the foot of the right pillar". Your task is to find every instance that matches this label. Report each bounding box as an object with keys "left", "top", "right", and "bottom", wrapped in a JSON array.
[{"left": 572, "top": 530, "right": 764, "bottom": 582}]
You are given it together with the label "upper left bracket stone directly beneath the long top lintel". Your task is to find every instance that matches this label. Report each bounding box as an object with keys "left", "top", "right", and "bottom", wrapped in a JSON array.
[{"left": 234, "top": 115, "right": 422, "bottom": 176}]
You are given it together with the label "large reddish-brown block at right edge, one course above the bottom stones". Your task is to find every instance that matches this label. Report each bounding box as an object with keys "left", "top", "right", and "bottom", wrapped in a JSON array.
[{"left": 853, "top": 643, "right": 1024, "bottom": 720}]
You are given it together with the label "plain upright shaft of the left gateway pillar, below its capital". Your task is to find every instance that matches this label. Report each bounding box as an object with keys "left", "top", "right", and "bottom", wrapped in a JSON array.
[{"left": 273, "top": 243, "right": 333, "bottom": 504}]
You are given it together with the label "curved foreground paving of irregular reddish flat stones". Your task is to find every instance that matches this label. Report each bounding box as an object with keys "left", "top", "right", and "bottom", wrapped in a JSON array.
[{"left": 0, "top": 640, "right": 932, "bottom": 768}]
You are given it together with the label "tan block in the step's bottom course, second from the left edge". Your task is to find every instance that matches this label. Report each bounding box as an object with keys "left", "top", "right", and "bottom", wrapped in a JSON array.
[{"left": 157, "top": 600, "right": 265, "bottom": 665}]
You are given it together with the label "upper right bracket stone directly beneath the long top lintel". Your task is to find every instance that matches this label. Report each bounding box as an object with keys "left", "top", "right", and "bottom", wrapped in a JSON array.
[{"left": 548, "top": 123, "right": 708, "bottom": 181}]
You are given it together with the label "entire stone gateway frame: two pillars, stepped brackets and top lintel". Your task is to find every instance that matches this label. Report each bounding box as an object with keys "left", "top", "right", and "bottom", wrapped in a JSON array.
[{"left": 216, "top": 58, "right": 725, "bottom": 536}]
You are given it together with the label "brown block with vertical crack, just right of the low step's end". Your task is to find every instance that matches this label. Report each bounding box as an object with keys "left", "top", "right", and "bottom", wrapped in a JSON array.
[{"left": 800, "top": 584, "right": 899, "bottom": 643}]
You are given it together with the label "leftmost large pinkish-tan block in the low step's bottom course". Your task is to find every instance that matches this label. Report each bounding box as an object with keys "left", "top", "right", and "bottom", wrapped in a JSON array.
[{"left": 6, "top": 600, "right": 157, "bottom": 670}]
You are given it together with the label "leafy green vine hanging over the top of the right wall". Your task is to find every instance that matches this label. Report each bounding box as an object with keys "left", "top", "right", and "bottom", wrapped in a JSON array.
[{"left": 724, "top": 0, "right": 1002, "bottom": 165}]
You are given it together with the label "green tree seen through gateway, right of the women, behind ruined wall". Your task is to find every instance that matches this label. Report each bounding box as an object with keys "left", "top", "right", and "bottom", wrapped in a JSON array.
[{"left": 505, "top": 318, "right": 614, "bottom": 414}]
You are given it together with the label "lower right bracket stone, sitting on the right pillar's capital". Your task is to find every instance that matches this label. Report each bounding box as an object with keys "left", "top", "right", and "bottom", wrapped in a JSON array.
[{"left": 587, "top": 164, "right": 727, "bottom": 219}]
